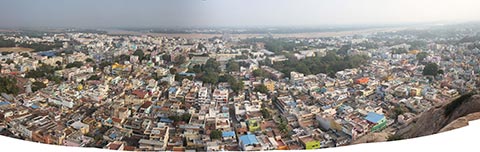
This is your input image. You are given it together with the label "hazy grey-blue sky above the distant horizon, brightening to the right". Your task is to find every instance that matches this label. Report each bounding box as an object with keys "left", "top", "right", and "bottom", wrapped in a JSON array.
[{"left": 0, "top": 0, "right": 480, "bottom": 27}]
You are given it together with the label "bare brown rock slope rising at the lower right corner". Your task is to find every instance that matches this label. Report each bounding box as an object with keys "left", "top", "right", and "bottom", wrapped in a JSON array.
[{"left": 397, "top": 93, "right": 480, "bottom": 139}]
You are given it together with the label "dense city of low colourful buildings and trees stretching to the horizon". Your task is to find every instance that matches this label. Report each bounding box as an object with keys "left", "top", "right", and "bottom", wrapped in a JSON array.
[{"left": 0, "top": 26, "right": 480, "bottom": 151}]
